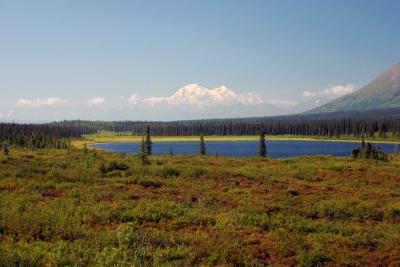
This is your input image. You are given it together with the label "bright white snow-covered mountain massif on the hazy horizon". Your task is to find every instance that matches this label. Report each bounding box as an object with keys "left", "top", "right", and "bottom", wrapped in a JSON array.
[{"left": 128, "top": 83, "right": 263, "bottom": 108}]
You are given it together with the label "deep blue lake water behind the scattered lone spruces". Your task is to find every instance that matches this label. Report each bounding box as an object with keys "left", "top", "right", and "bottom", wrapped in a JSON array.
[{"left": 91, "top": 140, "right": 400, "bottom": 158}]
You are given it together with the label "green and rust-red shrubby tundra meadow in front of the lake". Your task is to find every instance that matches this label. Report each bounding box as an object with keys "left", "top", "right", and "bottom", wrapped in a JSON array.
[{"left": 0, "top": 148, "right": 400, "bottom": 266}]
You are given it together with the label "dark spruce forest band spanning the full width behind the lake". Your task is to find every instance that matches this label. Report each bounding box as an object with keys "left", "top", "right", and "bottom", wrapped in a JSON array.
[{"left": 0, "top": 112, "right": 400, "bottom": 149}]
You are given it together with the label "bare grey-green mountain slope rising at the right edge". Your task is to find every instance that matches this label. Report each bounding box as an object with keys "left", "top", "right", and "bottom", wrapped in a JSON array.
[{"left": 305, "top": 63, "right": 400, "bottom": 113}]
